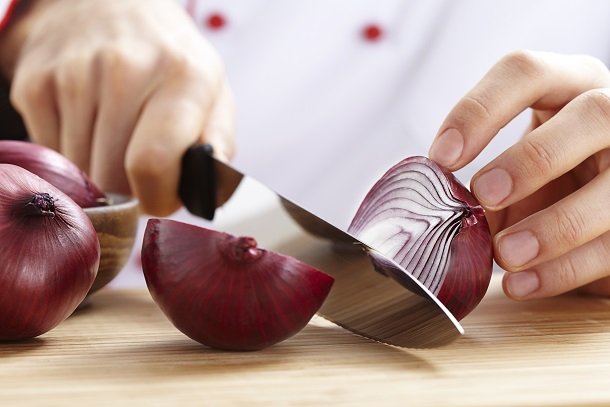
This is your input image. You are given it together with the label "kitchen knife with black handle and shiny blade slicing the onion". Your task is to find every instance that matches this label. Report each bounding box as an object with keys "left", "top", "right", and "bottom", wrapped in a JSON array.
[{"left": 178, "top": 144, "right": 464, "bottom": 348}]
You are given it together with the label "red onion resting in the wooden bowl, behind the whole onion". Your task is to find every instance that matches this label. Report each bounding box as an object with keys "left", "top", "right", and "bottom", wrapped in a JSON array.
[{"left": 0, "top": 140, "right": 107, "bottom": 208}]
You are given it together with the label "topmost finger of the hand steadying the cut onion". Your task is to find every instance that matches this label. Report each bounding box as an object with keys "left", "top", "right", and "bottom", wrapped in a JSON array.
[{"left": 429, "top": 51, "right": 610, "bottom": 170}]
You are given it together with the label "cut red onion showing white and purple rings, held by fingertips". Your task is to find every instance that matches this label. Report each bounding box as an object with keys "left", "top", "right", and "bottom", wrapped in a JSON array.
[{"left": 348, "top": 156, "right": 493, "bottom": 319}]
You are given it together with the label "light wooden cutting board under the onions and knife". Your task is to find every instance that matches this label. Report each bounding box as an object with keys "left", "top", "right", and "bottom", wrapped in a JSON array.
[{"left": 0, "top": 276, "right": 610, "bottom": 407}]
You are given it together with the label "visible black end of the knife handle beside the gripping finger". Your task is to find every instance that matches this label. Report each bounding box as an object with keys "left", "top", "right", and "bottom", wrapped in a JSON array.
[{"left": 178, "top": 144, "right": 216, "bottom": 220}]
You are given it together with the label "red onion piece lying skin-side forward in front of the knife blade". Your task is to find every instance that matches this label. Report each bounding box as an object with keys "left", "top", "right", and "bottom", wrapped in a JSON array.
[{"left": 141, "top": 219, "right": 334, "bottom": 351}]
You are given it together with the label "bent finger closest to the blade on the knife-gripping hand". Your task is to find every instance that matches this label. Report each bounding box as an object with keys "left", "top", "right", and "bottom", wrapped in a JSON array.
[{"left": 125, "top": 83, "right": 212, "bottom": 216}]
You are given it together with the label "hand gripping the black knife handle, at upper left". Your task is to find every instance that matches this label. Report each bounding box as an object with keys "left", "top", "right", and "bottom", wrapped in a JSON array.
[{"left": 0, "top": 0, "right": 233, "bottom": 216}]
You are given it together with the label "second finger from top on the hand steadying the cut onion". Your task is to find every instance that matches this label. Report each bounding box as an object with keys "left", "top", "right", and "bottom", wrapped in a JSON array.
[{"left": 471, "top": 89, "right": 610, "bottom": 210}]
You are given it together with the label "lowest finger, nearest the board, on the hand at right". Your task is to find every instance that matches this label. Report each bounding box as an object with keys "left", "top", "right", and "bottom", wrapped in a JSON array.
[{"left": 503, "top": 233, "right": 610, "bottom": 300}]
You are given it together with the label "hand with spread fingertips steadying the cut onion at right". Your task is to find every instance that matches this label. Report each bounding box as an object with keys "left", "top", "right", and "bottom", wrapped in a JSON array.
[{"left": 430, "top": 51, "right": 610, "bottom": 299}]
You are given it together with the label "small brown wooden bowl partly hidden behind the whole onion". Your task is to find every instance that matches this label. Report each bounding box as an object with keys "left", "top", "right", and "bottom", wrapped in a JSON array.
[{"left": 84, "top": 194, "right": 139, "bottom": 295}]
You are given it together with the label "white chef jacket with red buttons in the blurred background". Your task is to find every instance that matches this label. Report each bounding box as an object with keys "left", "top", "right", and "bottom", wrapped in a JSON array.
[{"left": 0, "top": 0, "right": 610, "bottom": 285}]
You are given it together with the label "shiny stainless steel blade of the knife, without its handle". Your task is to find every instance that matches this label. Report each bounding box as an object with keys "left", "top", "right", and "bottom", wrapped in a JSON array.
[{"left": 183, "top": 146, "right": 464, "bottom": 348}]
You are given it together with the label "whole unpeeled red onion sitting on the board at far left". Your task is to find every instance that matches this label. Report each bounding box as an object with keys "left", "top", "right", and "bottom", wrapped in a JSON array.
[{"left": 0, "top": 164, "right": 100, "bottom": 341}]
